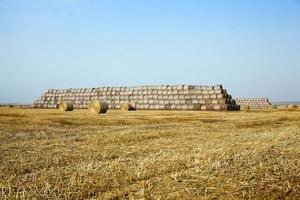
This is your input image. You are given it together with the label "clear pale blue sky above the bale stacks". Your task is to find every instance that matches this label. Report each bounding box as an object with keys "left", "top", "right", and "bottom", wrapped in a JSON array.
[{"left": 0, "top": 0, "right": 300, "bottom": 103}]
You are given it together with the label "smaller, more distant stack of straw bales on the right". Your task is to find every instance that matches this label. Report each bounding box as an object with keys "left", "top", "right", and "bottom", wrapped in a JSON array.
[{"left": 235, "top": 98, "right": 272, "bottom": 109}]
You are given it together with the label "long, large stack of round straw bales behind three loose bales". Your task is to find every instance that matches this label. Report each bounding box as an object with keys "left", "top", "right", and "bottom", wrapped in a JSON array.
[{"left": 34, "top": 85, "right": 239, "bottom": 110}]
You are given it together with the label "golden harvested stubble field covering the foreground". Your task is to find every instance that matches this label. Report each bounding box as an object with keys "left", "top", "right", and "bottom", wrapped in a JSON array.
[{"left": 0, "top": 108, "right": 300, "bottom": 199}]
